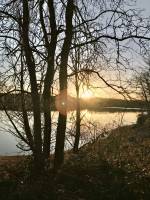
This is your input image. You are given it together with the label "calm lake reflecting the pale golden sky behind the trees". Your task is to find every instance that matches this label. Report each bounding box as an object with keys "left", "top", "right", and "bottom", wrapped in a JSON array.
[{"left": 0, "top": 110, "right": 139, "bottom": 155}]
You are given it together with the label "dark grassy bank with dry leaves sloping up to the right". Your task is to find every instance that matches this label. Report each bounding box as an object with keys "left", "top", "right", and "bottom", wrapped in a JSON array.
[{"left": 0, "top": 126, "right": 150, "bottom": 200}]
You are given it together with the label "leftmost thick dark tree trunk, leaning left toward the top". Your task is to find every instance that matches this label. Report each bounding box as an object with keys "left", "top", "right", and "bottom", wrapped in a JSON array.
[{"left": 22, "top": 0, "right": 44, "bottom": 175}]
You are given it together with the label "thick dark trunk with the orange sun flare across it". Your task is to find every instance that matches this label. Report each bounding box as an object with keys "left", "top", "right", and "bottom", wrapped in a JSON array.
[{"left": 54, "top": 0, "right": 74, "bottom": 171}]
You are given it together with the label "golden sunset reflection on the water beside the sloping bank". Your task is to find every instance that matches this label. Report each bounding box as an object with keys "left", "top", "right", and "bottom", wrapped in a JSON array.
[{"left": 67, "top": 110, "right": 139, "bottom": 148}]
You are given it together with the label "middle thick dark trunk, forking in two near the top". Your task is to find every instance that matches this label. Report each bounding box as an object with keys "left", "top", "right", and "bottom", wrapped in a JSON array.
[{"left": 39, "top": 0, "right": 57, "bottom": 159}]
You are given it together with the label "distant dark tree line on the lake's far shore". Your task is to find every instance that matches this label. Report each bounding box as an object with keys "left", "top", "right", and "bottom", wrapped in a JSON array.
[{"left": 0, "top": 93, "right": 150, "bottom": 112}]
